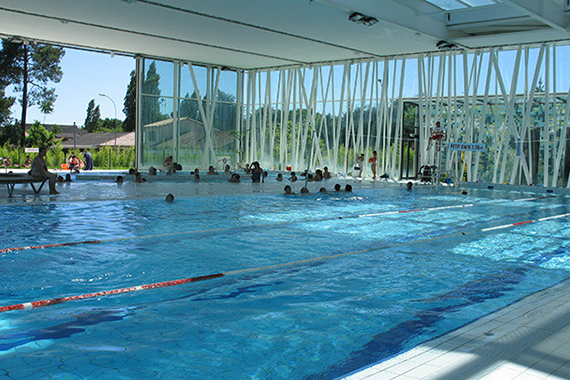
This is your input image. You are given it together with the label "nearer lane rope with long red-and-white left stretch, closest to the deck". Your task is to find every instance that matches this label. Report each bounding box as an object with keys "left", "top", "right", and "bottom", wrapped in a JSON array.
[{"left": 0, "top": 209, "right": 570, "bottom": 313}]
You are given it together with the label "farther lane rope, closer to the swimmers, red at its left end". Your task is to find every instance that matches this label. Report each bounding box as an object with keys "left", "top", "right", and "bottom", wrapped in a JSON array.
[{"left": 0, "top": 195, "right": 557, "bottom": 254}]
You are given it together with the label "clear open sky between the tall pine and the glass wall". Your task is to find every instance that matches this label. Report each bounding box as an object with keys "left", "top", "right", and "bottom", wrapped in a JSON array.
[{"left": 7, "top": 49, "right": 136, "bottom": 127}]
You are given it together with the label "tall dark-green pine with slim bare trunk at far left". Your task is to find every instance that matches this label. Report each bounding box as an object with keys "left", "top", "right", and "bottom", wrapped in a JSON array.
[{"left": 0, "top": 39, "right": 65, "bottom": 145}]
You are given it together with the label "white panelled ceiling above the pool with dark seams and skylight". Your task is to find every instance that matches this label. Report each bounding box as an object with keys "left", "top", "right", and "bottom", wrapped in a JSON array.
[{"left": 0, "top": 0, "right": 570, "bottom": 69}]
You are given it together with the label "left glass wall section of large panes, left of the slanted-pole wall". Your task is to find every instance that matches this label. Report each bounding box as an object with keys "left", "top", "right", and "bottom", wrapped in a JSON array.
[{"left": 138, "top": 59, "right": 238, "bottom": 170}]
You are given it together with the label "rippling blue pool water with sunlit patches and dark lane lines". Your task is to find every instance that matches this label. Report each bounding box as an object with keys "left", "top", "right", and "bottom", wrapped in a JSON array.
[{"left": 0, "top": 184, "right": 570, "bottom": 379}]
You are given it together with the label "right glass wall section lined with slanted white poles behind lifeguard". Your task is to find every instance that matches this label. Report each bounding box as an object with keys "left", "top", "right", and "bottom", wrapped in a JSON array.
[{"left": 237, "top": 44, "right": 570, "bottom": 187}]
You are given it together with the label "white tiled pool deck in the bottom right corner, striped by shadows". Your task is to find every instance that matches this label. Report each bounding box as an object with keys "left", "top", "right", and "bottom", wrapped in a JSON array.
[{"left": 344, "top": 280, "right": 570, "bottom": 380}]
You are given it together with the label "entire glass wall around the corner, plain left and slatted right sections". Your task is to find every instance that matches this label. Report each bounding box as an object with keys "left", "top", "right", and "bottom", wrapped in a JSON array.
[{"left": 139, "top": 43, "right": 570, "bottom": 187}]
